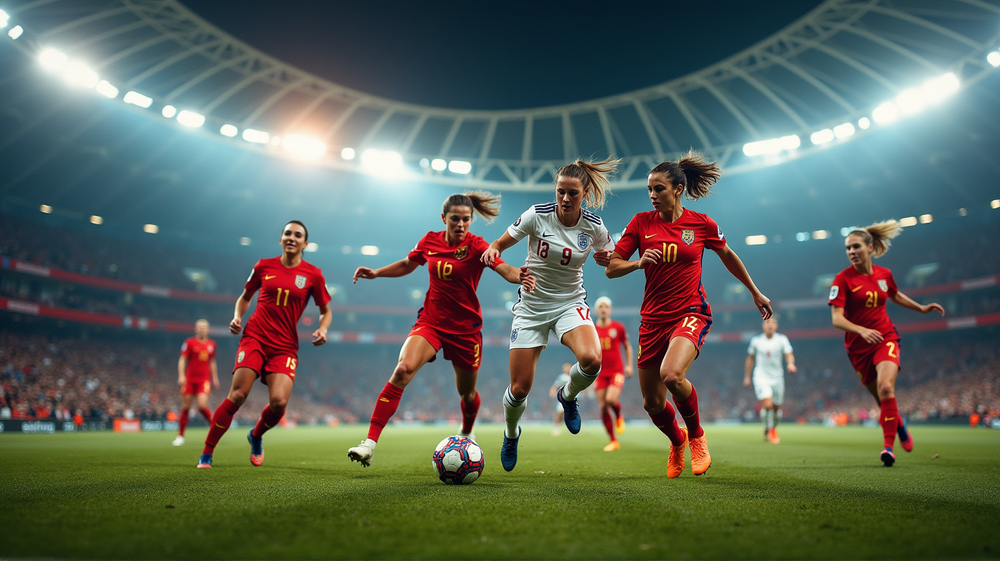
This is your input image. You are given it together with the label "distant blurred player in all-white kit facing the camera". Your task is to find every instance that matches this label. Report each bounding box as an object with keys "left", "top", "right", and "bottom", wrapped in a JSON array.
[{"left": 743, "top": 317, "right": 797, "bottom": 444}]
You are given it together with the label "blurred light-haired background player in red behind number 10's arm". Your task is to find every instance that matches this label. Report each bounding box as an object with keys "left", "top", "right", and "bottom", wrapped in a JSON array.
[{"left": 594, "top": 296, "right": 632, "bottom": 452}]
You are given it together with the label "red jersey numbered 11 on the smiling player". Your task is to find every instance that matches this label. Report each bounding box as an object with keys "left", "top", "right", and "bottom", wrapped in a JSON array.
[{"left": 243, "top": 257, "right": 330, "bottom": 353}]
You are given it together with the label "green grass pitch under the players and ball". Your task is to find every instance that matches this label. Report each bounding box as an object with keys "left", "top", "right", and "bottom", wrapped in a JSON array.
[{"left": 0, "top": 425, "right": 1000, "bottom": 559}]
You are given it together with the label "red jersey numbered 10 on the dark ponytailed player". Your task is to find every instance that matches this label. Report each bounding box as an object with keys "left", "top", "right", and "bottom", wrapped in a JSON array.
[{"left": 615, "top": 209, "right": 726, "bottom": 323}]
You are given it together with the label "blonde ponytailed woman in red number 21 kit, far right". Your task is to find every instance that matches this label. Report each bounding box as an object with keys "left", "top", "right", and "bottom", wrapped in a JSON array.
[{"left": 830, "top": 220, "right": 944, "bottom": 467}]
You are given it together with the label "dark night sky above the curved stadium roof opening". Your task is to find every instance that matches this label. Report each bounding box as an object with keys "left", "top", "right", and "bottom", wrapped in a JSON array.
[{"left": 185, "top": 0, "right": 820, "bottom": 109}]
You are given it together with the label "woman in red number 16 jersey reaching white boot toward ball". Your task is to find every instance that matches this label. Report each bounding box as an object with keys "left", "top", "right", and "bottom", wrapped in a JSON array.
[{"left": 347, "top": 193, "right": 534, "bottom": 467}]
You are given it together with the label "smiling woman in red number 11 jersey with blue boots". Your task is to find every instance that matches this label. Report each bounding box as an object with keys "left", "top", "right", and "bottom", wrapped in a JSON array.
[{"left": 198, "top": 220, "right": 332, "bottom": 468}]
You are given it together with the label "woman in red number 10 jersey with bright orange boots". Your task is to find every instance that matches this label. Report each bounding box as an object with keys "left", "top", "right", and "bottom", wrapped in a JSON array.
[{"left": 605, "top": 152, "right": 771, "bottom": 478}]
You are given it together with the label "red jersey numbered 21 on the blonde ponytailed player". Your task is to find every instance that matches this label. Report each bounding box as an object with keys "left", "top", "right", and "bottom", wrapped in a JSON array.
[{"left": 830, "top": 265, "right": 899, "bottom": 352}]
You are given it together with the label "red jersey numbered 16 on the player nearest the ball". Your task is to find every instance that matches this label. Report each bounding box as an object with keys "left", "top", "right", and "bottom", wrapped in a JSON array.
[{"left": 407, "top": 232, "right": 503, "bottom": 333}]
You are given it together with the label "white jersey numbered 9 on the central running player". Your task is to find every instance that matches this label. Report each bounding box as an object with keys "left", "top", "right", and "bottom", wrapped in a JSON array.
[{"left": 507, "top": 202, "right": 614, "bottom": 313}]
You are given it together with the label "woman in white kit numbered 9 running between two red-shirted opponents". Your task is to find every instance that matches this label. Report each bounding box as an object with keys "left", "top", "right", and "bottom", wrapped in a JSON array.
[{"left": 483, "top": 155, "right": 619, "bottom": 471}]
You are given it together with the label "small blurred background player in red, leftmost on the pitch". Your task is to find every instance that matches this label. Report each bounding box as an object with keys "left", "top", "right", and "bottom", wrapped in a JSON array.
[{"left": 173, "top": 319, "right": 219, "bottom": 446}]
